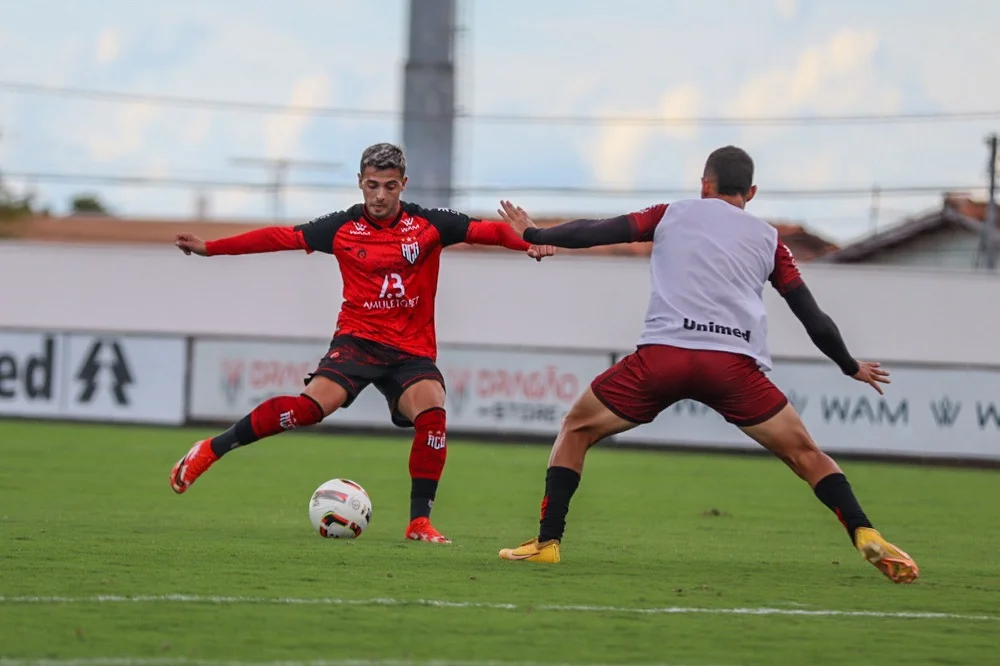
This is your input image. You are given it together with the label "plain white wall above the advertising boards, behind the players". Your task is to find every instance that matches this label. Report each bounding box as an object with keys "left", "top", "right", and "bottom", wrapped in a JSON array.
[{"left": 0, "top": 242, "right": 1000, "bottom": 366}]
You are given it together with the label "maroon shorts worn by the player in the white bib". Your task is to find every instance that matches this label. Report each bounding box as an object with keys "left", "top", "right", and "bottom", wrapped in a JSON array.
[{"left": 590, "top": 345, "right": 788, "bottom": 426}]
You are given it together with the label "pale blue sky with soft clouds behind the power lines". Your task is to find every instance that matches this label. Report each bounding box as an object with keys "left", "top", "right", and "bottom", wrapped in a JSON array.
[{"left": 0, "top": 0, "right": 1000, "bottom": 242}]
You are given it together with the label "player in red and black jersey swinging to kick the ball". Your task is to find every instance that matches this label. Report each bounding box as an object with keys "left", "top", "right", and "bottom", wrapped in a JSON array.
[{"left": 170, "top": 143, "right": 553, "bottom": 543}]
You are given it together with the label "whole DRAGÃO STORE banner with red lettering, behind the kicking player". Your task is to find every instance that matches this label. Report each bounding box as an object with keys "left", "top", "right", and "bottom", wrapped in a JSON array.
[{"left": 190, "top": 339, "right": 610, "bottom": 435}]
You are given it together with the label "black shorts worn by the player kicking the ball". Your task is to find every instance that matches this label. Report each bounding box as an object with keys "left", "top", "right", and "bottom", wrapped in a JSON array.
[{"left": 305, "top": 335, "right": 444, "bottom": 428}]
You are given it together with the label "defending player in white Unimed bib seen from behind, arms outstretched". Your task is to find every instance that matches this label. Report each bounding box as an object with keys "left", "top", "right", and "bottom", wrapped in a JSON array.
[{"left": 500, "top": 146, "right": 919, "bottom": 583}]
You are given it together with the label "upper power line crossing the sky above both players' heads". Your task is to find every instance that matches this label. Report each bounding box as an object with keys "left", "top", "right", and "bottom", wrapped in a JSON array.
[{"left": 0, "top": 81, "right": 1000, "bottom": 126}]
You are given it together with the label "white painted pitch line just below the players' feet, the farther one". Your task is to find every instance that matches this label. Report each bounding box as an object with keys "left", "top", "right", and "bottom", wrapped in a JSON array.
[{"left": 0, "top": 594, "right": 988, "bottom": 622}]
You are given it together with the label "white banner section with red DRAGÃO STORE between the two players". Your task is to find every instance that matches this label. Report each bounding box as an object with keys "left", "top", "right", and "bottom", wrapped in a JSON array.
[{"left": 438, "top": 348, "right": 611, "bottom": 435}]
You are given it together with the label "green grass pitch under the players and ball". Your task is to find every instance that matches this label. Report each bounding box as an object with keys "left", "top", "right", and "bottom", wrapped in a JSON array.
[{"left": 0, "top": 421, "right": 1000, "bottom": 666}]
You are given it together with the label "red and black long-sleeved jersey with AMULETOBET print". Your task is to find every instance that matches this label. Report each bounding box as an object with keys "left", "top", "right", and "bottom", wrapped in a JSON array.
[{"left": 206, "top": 203, "right": 530, "bottom": 359}]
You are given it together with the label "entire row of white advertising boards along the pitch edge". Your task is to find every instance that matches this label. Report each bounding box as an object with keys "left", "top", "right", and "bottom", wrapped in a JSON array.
[{"left": 0, "top": 329, "right": 1000, "bottom": 462}]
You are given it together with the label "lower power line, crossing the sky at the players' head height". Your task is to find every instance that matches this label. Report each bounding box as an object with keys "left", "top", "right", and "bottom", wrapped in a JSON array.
[{"left": 4, "top": 171, "right": 982, "bottom": 199}]
